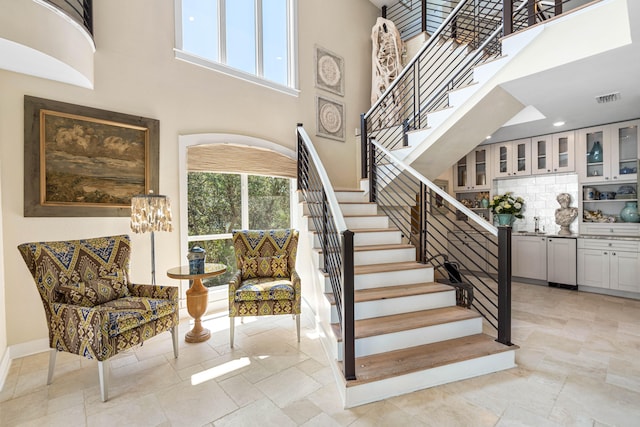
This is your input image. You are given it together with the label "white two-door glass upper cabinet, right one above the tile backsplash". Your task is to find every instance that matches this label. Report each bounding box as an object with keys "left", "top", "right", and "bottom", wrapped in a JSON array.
[{"left": 531, "top": 132, "right": 575, "bottom": 175}]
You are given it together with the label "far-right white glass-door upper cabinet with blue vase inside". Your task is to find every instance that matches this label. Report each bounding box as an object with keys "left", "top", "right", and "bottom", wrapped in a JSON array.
[{"left": 576, "top": 120, "right": 640, "bottom": 182}]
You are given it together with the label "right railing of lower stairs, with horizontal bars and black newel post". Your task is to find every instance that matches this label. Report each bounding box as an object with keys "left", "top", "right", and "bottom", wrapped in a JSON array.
[{"left": 369, "top": 139, "right": 511, "bottom": 345}]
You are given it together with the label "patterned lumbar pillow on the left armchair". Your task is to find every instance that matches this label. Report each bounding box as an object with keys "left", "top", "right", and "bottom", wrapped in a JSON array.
[{"left": 57, "top": 272, "right": 129, "bottom": 307}]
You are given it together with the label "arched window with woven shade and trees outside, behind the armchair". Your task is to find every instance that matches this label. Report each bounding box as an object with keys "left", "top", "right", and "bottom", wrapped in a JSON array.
[{"left": 179, "top": 133, "right": 297, "bottom": 290}]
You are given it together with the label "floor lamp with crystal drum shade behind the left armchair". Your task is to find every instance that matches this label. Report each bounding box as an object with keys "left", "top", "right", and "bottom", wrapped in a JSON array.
[{"left": 131, "top": 191, "right": 173, "bottom": 285}]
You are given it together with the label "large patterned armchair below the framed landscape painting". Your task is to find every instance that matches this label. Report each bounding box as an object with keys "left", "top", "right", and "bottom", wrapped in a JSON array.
[{"left": 18, "top": 235, "right": 178, "bottom": 402}]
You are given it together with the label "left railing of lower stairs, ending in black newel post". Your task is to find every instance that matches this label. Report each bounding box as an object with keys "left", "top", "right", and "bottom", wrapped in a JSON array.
[{"left": 297, "top": 124, "right": 356, "bottom": 380}]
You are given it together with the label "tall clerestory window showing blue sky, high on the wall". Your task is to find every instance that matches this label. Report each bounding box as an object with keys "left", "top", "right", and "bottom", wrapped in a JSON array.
[{"left": 176, "top": 0, "right": 297, "bottom": 94}]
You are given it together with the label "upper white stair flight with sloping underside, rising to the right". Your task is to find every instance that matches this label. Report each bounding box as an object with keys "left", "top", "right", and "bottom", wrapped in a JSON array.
[{"left": 363, "top": 0, "right": 630, "bottom": 179}]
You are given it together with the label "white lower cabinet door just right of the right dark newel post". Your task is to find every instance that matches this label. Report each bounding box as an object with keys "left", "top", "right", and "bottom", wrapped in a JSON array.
[{"left": 511, "top": 234, "right": 547, "bottom": 280}]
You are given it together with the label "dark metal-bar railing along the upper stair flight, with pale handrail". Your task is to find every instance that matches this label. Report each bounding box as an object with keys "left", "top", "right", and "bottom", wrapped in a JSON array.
[{"left": 361, "top": 0, "right": 502, "bottom": 178}]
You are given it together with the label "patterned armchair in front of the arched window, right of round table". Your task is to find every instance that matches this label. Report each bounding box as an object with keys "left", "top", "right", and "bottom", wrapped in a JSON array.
[{"left": 229, "top": 229, "right": 301, "bottom": 347}]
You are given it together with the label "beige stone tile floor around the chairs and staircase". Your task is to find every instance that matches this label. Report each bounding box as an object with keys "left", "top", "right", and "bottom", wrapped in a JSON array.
[{"left": 0, "top": 284, "right": 640, "bottom": 427}]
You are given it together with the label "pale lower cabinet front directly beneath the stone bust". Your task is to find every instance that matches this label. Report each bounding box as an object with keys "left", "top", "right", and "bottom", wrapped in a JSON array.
[{"left": 547, "top": 237, "right": 577, "bottom": 286}]
